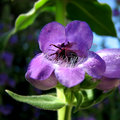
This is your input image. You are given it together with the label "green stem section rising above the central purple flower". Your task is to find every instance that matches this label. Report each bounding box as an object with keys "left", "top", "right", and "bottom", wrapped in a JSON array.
[{"left": 56, "top": 0, "right": 66, "bottom": 25}]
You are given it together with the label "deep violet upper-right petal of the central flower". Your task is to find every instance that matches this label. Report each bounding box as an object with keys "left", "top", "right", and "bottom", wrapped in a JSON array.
[{"left": 65, "top": 20, "right": 93, "bottom": 56}]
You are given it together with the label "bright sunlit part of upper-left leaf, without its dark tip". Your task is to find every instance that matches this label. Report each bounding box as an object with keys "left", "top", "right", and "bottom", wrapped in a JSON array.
[{"left": 15, "top": 0, "right": 48, "bottom": 31}]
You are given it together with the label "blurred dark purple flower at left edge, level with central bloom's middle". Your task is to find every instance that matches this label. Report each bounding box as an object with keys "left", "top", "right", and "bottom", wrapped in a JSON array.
[{"left": 1, "top": 52, "right": 13, "bottom": 67}]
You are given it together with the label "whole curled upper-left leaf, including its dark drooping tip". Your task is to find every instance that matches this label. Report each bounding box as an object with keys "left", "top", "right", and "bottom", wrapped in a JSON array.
[{"left": 0, "top": 0, "right": 49, "bottom": 50}]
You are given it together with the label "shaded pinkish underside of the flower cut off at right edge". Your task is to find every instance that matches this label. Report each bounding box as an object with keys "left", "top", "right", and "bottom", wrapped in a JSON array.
[{"left": 96, "top": 77, "right": 120, "bottom": 91}]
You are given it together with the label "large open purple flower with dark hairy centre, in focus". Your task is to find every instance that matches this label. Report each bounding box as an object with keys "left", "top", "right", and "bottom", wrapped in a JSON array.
[{"left": 25, "top": 21, "right": 105, "bottom": 90}]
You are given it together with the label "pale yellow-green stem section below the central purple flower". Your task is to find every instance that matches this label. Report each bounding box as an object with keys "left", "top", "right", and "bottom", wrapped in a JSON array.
[{"left": 57, "top": 88, "right": 72, "bottom": 120}]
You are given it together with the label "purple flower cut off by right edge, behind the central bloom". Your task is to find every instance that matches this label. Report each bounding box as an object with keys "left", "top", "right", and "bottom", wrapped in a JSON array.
[{"left": 97, "top": 49, "right": 120, "bottom": 91}]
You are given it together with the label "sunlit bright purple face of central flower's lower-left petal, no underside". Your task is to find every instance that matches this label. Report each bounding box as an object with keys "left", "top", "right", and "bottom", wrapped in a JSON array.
[{"left": 26, "top": 54, "right": 54, "bottom": 80}]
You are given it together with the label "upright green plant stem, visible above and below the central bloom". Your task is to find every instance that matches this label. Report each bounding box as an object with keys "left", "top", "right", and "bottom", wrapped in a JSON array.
[{"left": 56, "top": 0, "right": 72, "bottom": 120}]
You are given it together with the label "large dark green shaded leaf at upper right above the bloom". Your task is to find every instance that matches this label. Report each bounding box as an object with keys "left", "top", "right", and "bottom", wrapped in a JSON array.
[{"left": 66, "top": 0, "right": 116, "bottom": 36}]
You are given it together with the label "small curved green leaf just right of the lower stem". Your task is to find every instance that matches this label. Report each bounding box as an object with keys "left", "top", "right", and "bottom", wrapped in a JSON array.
[{"left": 74, "top": 91, "right": 83, "bottom": 113}]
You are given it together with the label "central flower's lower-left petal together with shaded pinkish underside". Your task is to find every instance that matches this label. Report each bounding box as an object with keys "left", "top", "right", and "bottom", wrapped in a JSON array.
[{"left": 25, "top": 54, "right": 57, "bottom": 89}]
